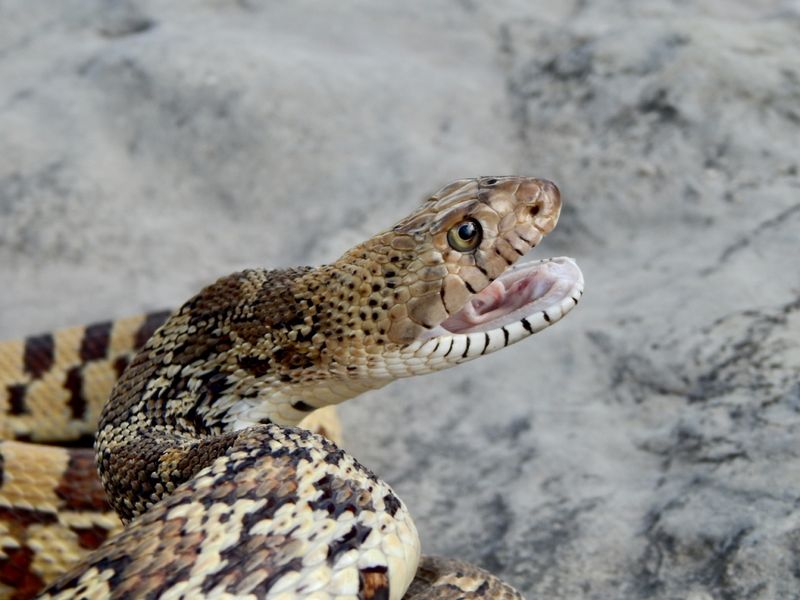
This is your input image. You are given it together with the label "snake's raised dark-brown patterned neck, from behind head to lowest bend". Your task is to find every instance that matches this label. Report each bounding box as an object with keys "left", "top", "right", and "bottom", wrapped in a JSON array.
[{"left": 95, "top": 259, "right": 412, "bottom": 520}]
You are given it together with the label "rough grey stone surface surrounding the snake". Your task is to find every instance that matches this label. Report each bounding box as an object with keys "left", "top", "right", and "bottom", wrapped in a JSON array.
[{"left": 0, "top": 0, "right": 800, "bottom": 600}]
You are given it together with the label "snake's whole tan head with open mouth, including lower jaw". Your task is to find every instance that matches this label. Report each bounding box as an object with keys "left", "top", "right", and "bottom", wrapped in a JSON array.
[{"left": 338, "top": 172, "right": 583, "bottom": 376}]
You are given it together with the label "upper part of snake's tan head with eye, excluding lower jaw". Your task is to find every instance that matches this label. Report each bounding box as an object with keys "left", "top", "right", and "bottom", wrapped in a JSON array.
[{"left": 334, "top": 177, "right": 561, "bottom": 348}]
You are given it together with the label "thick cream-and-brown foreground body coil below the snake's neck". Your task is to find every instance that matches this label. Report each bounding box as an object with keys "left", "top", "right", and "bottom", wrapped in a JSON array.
[{"left": 45, "top": 425, "right": 416, "bottom": 599}]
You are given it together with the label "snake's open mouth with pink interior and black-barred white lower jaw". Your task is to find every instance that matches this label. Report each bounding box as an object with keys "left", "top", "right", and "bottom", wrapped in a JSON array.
[{"left": 416, "top": 257, "right": 583, "bottom": 359}]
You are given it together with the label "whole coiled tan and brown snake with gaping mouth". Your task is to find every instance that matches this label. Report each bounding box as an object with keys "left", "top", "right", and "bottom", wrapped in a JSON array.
[{"left": 0, "top": 176, "right": 584, "bottom": 600}]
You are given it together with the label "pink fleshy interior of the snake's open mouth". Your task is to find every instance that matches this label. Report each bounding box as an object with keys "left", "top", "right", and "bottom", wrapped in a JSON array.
[{"left": 429, "top": 257, "right": 583, "bottom": 335}]
